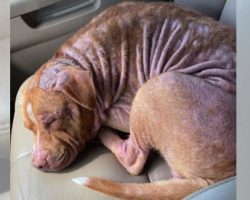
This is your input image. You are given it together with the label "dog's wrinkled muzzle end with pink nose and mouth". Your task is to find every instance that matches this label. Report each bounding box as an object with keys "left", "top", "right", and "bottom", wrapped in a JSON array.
[{"left": 32, "top": 150, "right": 76, "bottom": 172}]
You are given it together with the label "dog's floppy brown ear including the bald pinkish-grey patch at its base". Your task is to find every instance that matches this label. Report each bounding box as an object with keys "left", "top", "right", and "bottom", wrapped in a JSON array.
[{"left": 39, "top": 65, "right": 96, "bottom": 110}]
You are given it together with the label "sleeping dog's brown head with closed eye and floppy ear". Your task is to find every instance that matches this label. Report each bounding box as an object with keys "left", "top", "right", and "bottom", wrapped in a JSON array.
[{"left": 23, "top": 62, "right": 96, "bottom": 171}]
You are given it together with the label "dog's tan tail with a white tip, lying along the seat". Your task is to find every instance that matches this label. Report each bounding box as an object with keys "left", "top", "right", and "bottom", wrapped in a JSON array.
[{"left": 73, "top": 177, "right": 209, "bottom": 200}]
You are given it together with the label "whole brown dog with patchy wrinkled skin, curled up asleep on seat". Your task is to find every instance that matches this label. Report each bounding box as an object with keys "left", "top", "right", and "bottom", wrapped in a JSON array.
[{"left": 23, "top": 2, "right": 236, "bottom": 200}]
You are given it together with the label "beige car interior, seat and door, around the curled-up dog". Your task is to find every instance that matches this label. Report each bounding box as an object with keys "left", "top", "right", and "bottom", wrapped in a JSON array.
[{"left": 8, "top": 0, "right": 236, "bottom": 200}]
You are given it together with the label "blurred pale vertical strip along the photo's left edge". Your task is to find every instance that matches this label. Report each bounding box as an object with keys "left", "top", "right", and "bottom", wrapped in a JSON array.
[{"left": 0, "top": 0, "right": 10, "bottom": 199}]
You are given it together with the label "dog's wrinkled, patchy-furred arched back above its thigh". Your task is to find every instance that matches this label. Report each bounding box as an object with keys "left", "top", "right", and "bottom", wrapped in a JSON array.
[{"left": 56, "top": 2, "right": 236, "bottom": 96}]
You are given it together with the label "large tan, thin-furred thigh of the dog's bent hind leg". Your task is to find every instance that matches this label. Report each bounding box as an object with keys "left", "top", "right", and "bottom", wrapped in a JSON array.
[{"left": 130, "top": 72, "right": 236, "bottom": 181}]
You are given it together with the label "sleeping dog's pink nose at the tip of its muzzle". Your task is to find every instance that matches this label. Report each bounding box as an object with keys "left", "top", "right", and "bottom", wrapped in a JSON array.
[{"left": 32, "top": 150, "right": 48, "bottom": 170}]
